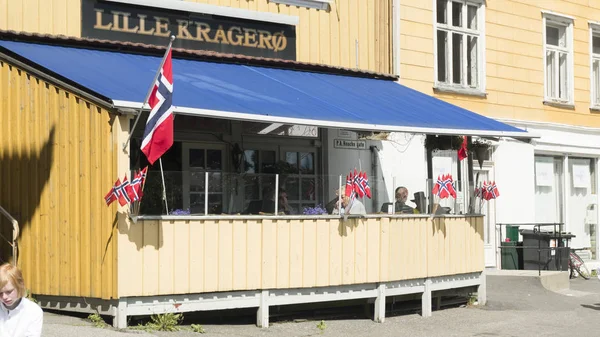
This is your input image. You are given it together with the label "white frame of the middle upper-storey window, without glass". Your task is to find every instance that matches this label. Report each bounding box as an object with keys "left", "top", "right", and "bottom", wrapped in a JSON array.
[{"left": 542, "top": 11, "right": 575, "bottom": 107}]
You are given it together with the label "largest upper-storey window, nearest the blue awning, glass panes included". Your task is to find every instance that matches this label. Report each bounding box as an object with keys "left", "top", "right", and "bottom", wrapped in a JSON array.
[{"left": 435, "top": 0, "right": 485, "bottom": 91}]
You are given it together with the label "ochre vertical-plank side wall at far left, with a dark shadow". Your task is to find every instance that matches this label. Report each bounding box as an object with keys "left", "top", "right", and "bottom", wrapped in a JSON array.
[{"left": 0, "top": 61, "right": 117, "bottom": 298}]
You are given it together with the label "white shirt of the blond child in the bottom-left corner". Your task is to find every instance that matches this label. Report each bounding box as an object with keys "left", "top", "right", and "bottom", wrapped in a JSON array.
[{"left": 0, "top": 297, "right": 44, "bottom": 337}]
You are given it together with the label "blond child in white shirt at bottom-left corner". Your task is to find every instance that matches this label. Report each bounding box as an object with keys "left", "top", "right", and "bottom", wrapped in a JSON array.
[{"left": 0, "top": 263, "right": 44, "bottom": 337}]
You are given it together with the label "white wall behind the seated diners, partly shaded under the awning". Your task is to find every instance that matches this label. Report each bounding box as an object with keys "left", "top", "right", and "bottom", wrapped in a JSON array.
[{"left": 325, "top": 129, "right": 427, "bottom": 213}]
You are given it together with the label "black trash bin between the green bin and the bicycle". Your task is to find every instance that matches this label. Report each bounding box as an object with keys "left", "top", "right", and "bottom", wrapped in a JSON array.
[{"left": 520, "top": 229, "right": 575, "bottom": 271}]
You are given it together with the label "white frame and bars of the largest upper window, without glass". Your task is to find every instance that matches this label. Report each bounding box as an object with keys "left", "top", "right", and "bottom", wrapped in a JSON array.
[{"left": 433, "top": 0, "right": 486, "bottom": 96}]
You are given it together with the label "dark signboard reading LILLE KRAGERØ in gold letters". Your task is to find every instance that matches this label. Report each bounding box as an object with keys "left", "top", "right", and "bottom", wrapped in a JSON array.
[{"left": 81, "top": 0, "right": 296, "bottom": 60}]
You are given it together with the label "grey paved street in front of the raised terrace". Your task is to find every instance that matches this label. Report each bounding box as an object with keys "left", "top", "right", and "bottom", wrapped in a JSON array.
[{"left": 43, "top": 276, "right": 600, "bottom": 337}]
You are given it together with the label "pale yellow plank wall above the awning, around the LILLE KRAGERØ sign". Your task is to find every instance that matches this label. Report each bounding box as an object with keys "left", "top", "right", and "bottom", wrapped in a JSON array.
[{"left": 0, "top": 0, "right": 392, "bottom": 73}]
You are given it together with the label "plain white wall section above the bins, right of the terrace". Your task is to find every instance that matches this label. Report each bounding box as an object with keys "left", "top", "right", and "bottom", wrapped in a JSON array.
[{"left": 494, "top": 140, "right": 535, "bottom": 224}]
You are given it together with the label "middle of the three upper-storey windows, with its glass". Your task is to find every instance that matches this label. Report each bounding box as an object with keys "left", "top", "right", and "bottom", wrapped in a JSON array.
[{"left": 543, "top": 13, "right": 573, "bottom": 104}]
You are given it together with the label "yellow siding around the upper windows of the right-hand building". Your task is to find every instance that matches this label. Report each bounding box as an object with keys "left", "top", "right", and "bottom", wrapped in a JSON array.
[{"left": 400, "top": 0, "right": 600, "bottom": 127}]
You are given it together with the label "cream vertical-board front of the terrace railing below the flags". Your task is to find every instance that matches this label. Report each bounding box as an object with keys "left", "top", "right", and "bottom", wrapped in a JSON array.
[{"left": 118, "top": 217, "right": 484, "bottom": 297}]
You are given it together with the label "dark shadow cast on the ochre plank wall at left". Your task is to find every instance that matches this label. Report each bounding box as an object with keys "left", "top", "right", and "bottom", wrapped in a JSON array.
[{"left": 0, "top": 126, "right": 55, "bottom": 262}]
